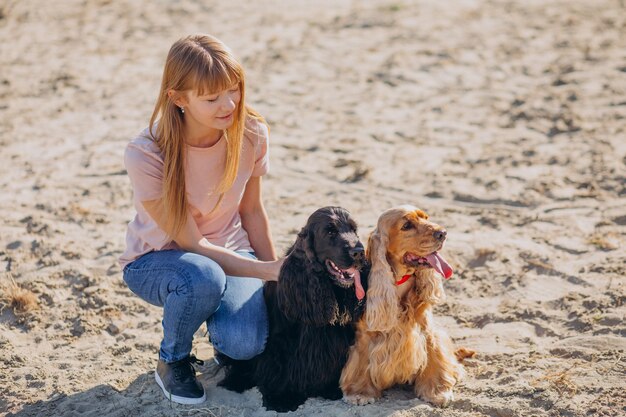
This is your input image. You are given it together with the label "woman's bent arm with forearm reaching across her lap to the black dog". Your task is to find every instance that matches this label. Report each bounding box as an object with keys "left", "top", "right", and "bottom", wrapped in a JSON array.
[{"left": 142, "top": 200, "right": 282, "bottom": 281}]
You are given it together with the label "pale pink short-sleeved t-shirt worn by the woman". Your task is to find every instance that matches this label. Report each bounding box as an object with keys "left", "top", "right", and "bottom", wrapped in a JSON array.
[{"left": 119, "top": 119, "right": 269, "bottom": 268}]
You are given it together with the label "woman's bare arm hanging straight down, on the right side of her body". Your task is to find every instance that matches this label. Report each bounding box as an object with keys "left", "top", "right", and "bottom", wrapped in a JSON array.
[{"left": 239, "top": 177, "right": 276, "bottom": 261}]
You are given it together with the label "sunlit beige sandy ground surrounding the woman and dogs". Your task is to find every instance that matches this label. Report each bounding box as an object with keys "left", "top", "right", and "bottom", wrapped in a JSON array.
[{"left": 0, "top": 0, "right": 626, "bottom": 417}]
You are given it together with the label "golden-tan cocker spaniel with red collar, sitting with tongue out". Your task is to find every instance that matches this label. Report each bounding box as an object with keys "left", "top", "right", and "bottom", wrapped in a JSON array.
[{"left": 341, "top": 206, "right": 474, "bottom": 406}]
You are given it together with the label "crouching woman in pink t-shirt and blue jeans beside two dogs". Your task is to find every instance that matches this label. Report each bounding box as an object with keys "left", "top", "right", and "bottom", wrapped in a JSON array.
[{"left": 120, "top": 35, "right": 282, "bottom": 404}]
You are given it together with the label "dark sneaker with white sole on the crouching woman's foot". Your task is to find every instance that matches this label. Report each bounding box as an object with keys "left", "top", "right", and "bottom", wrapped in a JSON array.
[{"left": 154, "top": 355, "right": 206, "bottom": 404}]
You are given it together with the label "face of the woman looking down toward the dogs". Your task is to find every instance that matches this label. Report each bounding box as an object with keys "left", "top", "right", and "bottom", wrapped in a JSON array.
[{"left": 185, "top": 84, "right": 241, "bottom": 130}]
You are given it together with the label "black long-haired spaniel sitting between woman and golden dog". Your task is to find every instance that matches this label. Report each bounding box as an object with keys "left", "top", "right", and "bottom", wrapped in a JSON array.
[{"left": 219, "top": 207, "right": 369, "bottom": 412}]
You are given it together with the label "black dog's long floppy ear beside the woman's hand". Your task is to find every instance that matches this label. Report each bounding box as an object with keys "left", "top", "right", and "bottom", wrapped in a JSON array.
[{"left": 277, "top": 254, "right": 339, "bottom": 326}]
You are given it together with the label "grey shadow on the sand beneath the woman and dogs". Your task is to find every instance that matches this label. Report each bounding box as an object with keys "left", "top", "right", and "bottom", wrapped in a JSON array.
[{"left": 7, "top": 371, "right": 422, "bottom": 417}]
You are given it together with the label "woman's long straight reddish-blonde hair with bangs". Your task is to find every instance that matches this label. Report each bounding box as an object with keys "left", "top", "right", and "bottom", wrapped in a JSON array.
[{"left": 149, "top": 35, "right": 265, "bottom": 239}]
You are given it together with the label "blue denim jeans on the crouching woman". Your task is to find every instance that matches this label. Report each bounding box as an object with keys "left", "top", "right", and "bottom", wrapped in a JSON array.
[{"left": 124, "top": 250, "right": 268, "bottom": 363}]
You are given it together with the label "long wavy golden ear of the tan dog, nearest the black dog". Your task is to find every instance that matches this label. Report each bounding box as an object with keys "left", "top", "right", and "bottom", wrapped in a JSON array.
[{"left": 365, "top": 227, "right": 400, "bottom": 331}]
